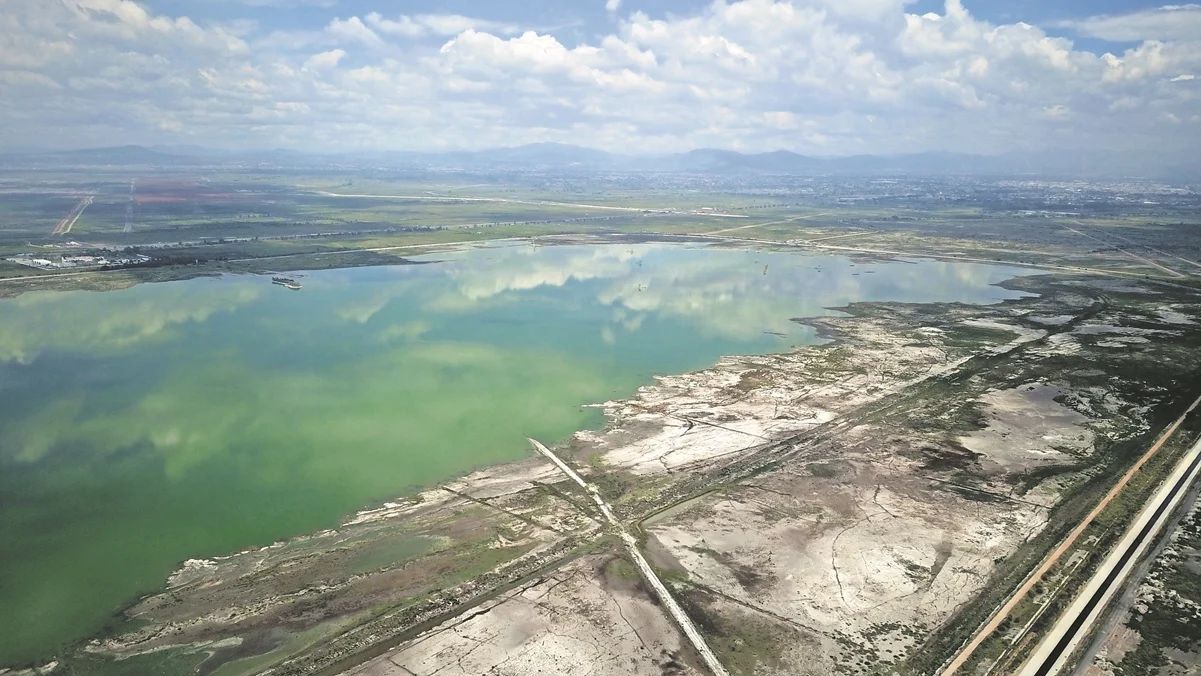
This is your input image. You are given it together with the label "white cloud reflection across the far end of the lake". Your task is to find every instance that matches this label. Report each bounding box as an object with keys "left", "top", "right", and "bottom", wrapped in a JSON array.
[{"left": 426, "top": 244, "right": 1016, "bottom": 341}]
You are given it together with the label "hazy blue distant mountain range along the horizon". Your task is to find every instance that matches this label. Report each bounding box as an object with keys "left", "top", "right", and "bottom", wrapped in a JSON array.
[{"left": 0, "top": 143, "right": 1201, "bottom": 180}]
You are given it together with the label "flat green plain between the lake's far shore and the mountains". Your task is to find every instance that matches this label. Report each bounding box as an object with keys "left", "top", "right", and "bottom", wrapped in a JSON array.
[{"left": 0, "top": 168, "right": 1201, "bottom": 295}]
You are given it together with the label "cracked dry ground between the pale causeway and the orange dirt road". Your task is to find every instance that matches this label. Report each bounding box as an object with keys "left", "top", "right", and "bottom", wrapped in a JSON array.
[{"left": 644, "top": 277, "right": 1201, "bottom": 675}]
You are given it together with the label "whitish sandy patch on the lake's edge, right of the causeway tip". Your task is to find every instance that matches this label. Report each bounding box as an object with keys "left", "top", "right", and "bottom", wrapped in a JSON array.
[{"left": 575, "top": 319, "right": 1045, "bottom": 474}]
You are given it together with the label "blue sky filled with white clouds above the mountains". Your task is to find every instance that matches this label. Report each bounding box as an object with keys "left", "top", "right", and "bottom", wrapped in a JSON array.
[{"left": 0, "top": 0, "right": 1201, "bottom": 157}]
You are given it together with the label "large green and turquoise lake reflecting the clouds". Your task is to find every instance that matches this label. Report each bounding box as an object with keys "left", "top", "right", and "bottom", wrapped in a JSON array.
[{"left": 0, "top": 244, "right": 1028, "bottom": 665}]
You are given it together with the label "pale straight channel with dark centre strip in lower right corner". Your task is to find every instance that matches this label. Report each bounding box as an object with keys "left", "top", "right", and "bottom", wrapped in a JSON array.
[{"left": 1020, "top": 441, "right": 1201, "bottom": 676}]
